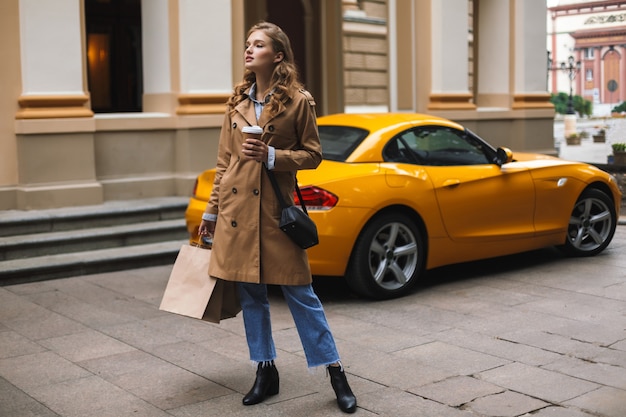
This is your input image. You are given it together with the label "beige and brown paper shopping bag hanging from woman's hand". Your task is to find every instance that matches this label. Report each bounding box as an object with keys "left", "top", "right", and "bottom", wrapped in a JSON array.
[{"left": 159, "top": 245, "right": 241, "bottom": 323}]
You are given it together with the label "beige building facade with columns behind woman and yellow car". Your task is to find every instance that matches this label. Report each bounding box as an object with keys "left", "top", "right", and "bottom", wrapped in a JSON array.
[{"left": 0, "top": 0, "right": 554, "bottom": 210}]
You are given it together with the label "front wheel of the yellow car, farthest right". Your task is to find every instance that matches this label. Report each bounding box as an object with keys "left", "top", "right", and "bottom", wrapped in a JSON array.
[{"left": 559, "top": 188, "right": 617, "bottom": 257}]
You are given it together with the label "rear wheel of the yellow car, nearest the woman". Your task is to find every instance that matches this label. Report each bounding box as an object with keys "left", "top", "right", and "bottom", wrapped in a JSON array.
[{"left": 346, "top": 212, "right": 426, "bottom": 300}]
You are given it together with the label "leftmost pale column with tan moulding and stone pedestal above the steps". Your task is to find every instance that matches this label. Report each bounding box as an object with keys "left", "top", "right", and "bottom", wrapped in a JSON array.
[{"left": 15, "top": 0, "right": 103, "bottom": 209}]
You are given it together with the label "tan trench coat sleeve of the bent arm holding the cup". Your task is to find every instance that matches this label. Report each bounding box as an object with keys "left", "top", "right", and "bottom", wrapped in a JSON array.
[{"left": 274, "top": 90, "right": 322, "bottom": 171}]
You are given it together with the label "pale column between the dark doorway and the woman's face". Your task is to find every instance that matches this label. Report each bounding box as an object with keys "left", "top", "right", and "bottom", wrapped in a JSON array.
[{"left": 141, "top": 0, "right": 234, "bottom": 115}]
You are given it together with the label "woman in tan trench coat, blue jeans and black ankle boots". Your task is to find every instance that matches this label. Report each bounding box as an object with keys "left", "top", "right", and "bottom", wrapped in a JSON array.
[{"left": 200, "top": 22, "right": 356, "bottom": 413}]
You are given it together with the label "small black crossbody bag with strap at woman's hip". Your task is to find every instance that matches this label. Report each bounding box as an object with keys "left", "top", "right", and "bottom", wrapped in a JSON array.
[{"left": 263, "top": 164, "right": 319, "bottom": 249}]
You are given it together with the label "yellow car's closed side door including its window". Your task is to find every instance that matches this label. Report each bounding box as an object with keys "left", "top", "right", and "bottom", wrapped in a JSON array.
[{"left": 392, "top": 126, "right": 535, "bottom": 242}]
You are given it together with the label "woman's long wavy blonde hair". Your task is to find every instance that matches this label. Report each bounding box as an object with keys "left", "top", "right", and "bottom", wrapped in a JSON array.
[{"left": 227, "top": 22, "right": 302, "bottom": 115}]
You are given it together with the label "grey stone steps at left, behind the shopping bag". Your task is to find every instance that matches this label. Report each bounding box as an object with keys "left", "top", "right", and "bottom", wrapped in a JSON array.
[{"left": 0, "top": 197, "right": 189, "bottom": 285}]
